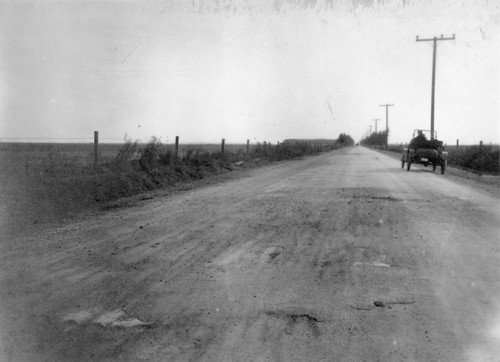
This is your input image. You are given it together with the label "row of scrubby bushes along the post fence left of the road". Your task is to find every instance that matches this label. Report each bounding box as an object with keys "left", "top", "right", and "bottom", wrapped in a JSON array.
[{"left": 71, "top": 131, "right": 351, "bottom": 202}]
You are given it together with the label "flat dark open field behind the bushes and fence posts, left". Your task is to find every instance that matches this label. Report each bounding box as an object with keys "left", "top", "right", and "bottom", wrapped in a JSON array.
[{"left": 0, "top": 143, "right": 284, "bottom": 232}]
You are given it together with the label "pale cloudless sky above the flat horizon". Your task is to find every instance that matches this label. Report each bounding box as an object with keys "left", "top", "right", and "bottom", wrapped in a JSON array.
[{"left": 0, "top": 0, "right": 500, "bottom": 144}]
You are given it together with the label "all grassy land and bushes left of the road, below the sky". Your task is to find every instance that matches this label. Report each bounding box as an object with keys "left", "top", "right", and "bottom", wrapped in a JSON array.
[{"left": 0, "top": 134, "right": 354, "bottom": 232}]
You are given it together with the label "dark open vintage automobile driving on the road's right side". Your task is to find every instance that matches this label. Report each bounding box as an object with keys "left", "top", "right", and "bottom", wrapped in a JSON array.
[{"left": 401, "top": 129, "right": 448, "bottom": 174}]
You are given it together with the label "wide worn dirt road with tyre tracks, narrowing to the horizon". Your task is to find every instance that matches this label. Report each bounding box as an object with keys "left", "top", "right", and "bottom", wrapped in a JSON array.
[{"left": 0, "top": 147, "right": 500, "bottom": 361}]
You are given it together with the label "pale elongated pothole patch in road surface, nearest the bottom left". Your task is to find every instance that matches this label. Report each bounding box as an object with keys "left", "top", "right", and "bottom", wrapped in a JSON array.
[{"left": 62, "top": 309, "right": 151, "bottom": 328}]
